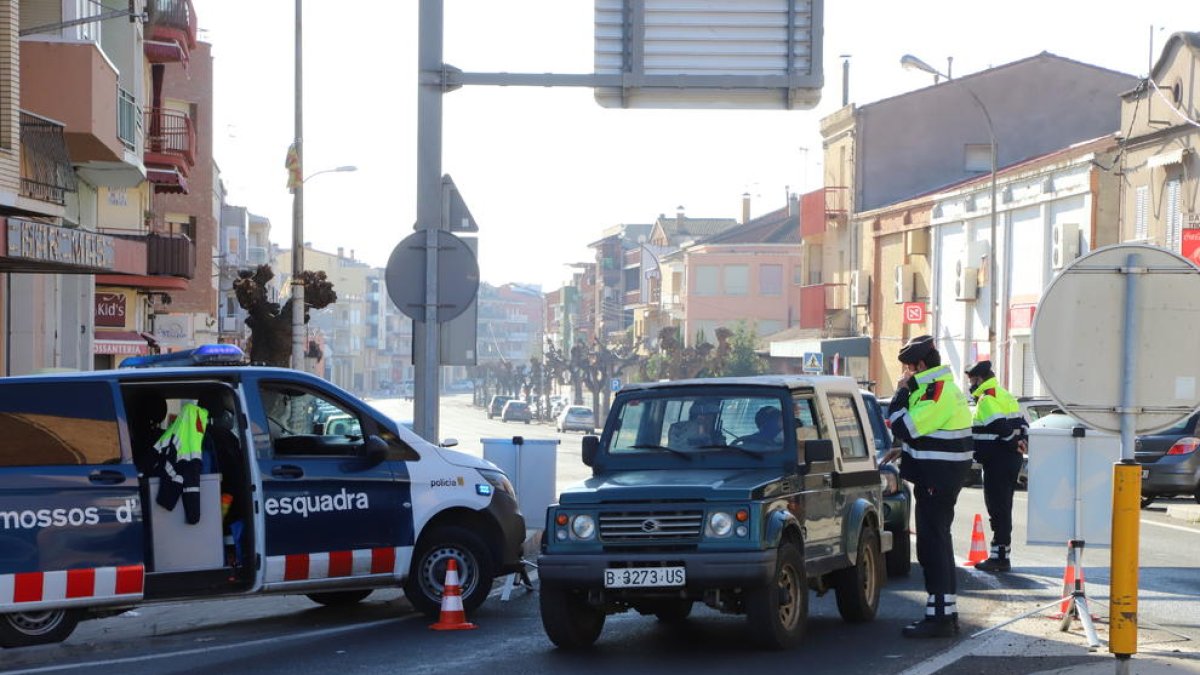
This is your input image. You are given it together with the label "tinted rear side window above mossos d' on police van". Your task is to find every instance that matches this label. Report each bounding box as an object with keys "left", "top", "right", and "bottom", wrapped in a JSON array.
[{"left": 0, "top": 382, "right": 121, "bottom": 466}]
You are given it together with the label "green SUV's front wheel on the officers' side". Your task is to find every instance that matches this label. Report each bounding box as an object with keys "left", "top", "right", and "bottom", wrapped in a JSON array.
[{"left": 745, "top": 542, "right": 809, "bottom": 650}]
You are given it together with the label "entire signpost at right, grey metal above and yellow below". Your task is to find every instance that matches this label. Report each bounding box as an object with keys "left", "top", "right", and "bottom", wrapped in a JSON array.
[{"left": 1109, "top": 253, "right": 1146, "bottom": 661}]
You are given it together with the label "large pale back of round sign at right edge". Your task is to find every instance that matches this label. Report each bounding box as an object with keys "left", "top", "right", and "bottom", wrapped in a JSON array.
[{"left": 1033, "top": 244, "right": 1200, "bottom": 434}]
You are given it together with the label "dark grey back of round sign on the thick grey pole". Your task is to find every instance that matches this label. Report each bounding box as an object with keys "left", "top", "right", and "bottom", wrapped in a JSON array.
[{"left": 384, "top": 229, "right": 479, "bottom": 323}]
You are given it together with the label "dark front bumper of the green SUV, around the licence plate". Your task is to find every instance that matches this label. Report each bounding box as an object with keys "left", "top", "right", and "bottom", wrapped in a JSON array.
[{"left": 538, "top": 549, "right": 778, "bottom": 591}]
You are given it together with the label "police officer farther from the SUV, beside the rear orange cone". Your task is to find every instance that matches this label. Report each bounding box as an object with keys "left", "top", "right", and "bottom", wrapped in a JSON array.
[{"left": 967, "top": 360, "right": 1030, "bottom": 572}]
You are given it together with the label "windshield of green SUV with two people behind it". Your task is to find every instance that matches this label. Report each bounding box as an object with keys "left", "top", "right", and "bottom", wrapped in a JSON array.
[{"left": 608, "top": 393, "right": 794, "bottom": 458}]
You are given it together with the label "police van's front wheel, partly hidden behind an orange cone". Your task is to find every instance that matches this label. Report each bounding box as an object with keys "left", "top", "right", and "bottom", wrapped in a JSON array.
[{"left": 404, "top": 525, "right": 496, "bottom": 617}]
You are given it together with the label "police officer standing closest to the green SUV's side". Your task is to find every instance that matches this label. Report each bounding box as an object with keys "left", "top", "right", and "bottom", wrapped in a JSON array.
[{"left": 884, "top": 335, "right": 972, "bottom": 638}]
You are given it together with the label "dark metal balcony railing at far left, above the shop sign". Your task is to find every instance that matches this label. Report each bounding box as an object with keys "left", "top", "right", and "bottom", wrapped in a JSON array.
[{"left": 20, "top": 110, "right": 77, "bottom": 205}]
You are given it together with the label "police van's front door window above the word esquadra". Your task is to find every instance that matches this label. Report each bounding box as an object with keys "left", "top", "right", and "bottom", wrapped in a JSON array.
[{"left": 259, "top": 383, "right": 362, "bottom": 456}]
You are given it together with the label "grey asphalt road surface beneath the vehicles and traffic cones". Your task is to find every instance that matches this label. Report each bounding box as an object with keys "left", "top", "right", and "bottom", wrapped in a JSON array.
[{"left": 0, "top": 396, "right": 1200, "bottom": 675}]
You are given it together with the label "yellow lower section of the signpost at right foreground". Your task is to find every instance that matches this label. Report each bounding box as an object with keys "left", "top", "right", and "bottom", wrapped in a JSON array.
[{"left": 1109, "top": 462, "right": 1141, "bottom": 657}]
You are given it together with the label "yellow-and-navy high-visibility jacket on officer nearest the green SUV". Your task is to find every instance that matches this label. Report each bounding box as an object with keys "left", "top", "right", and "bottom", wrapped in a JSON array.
[{"left": 888, "top": 365, "right": 974, "bottom": 490}]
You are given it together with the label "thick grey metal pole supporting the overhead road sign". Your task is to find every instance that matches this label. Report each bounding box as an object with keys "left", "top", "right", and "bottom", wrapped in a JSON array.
[{"left": 413, "top": 0, "right": 444, "bottom": 443}]
